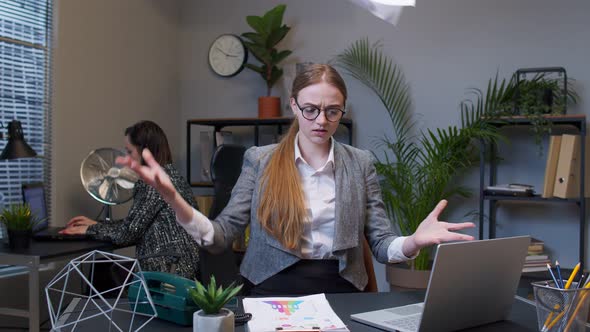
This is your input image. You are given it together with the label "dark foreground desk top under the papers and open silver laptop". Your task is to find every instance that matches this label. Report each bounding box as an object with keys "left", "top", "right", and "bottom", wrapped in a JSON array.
[{"left": 55, "top": 291, "right": 560, "bottom": 332}]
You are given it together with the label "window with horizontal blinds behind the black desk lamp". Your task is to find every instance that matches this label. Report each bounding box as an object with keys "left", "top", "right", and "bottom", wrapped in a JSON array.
[{"left": 0, "top": 0, "right": 53, "bottom": 240}]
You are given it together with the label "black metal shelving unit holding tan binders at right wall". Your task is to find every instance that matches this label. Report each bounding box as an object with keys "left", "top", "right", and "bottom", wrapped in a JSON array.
[{"left": 479, "top": 115, "right": 586, "bottom": 267}]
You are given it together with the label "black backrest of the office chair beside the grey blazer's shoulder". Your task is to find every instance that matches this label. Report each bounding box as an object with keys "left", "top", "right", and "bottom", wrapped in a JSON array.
[{"left": 209, "top": 144, "right": 246, "bottom": 219}]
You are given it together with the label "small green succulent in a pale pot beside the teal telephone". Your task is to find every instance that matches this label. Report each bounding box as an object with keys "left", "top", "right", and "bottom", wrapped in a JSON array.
[{"left": 189, "top": 276, "right": 242, "bottom": 332}]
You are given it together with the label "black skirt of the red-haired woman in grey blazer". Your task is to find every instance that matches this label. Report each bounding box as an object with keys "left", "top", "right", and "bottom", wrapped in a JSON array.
[{"left": 250, "top": 259, "right": 359, "bottom": 296}]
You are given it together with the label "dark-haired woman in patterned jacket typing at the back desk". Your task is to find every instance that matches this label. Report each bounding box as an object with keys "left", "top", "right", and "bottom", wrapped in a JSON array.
[{"left": 62, "top": 121, "right": 199, "bottom": 279}]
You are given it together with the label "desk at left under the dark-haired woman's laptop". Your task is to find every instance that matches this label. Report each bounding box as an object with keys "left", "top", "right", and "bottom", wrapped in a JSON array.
[{"left": 0, "top": 240, "right": 113, "bottom": 332}]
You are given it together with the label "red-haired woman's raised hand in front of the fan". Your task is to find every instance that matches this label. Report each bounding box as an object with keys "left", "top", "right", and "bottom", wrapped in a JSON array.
[{"left": 115, "top": 149, "right": 177, "bottom": 203}]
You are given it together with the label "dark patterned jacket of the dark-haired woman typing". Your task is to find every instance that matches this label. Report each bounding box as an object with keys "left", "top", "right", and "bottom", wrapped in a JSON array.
[{"left": 86, "top": 164, "right": 199, "bottom": 280}]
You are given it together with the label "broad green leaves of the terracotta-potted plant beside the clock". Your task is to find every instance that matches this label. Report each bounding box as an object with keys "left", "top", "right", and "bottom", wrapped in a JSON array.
[{"left": 242, "top": 5, "right": 291, "bottom": 96}]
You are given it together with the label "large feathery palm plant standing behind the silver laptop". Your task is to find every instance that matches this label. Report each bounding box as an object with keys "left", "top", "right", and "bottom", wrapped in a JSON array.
[{"left": 336, "top": 39, "right": 506, "bottom": 270}]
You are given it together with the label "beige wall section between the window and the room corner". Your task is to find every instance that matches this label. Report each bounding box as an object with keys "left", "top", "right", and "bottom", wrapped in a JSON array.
[{"left": 52, "top": 0, "right": 182, "bottom": 225}]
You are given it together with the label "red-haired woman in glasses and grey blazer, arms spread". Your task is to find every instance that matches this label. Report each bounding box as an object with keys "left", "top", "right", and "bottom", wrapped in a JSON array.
[{"left": 119, "top": 64, "right": 474, "bottom": 295}]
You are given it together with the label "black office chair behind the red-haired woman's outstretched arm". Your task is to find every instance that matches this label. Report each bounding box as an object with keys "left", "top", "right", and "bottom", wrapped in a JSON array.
[{"left": 199, "top": 144, "right": 246, "bottom": 288}]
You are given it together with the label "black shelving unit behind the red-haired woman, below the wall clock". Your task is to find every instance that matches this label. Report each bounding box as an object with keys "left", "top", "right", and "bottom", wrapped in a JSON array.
[{"left": 186, "top": 117, "right": 352, "bottom": 187}]
